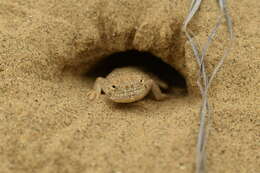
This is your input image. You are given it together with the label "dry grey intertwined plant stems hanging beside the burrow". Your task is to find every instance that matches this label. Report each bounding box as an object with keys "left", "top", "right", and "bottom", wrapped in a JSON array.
[{"left": 182, "top": 0, "right": 233, "bottom": 173}]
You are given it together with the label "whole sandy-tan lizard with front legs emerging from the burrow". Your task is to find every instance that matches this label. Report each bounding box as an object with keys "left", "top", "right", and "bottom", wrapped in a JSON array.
[{"left": 87, "top": 66, "right": 168, "bottom": 103}]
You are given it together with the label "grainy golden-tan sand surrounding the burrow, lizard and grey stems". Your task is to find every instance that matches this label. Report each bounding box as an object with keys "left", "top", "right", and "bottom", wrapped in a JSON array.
[{"left": 0, "top": 0, "right": 260, "bottom": 173}]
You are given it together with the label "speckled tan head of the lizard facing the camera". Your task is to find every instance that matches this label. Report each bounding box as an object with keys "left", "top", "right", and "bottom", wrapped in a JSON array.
[{"left": 102, "top": 74, "right": 152, "bottom": 103}]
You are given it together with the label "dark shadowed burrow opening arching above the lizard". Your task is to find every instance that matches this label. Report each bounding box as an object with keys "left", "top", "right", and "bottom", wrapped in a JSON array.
[{"left": 84, "top": 50, "right": 187, "bottom": 95}]
